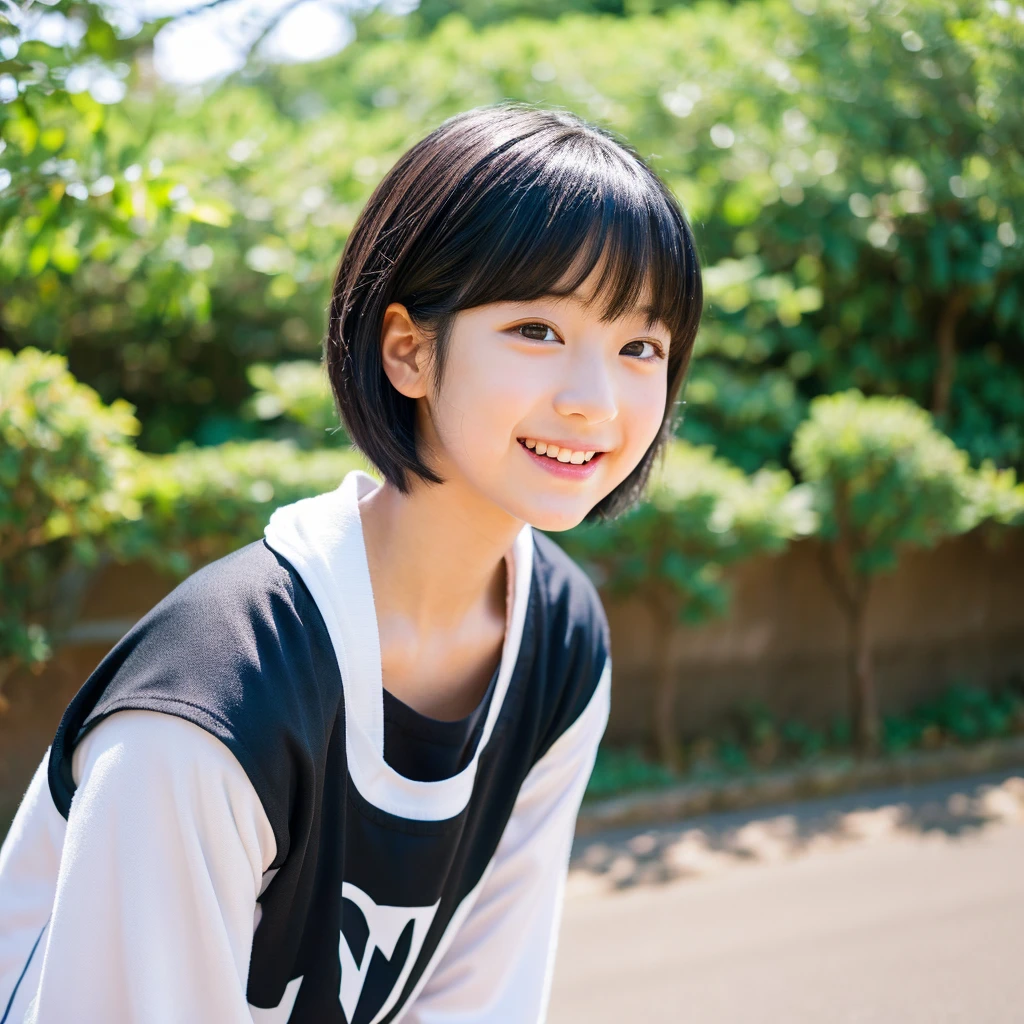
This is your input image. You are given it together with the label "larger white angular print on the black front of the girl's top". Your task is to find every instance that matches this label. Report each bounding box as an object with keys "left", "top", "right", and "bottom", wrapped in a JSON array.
[{"left": 338, "top": 882, "right": 440, "bottom": 1024}]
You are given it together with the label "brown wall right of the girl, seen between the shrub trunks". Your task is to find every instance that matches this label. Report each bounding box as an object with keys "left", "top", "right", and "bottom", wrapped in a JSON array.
[{"left": 607, "top": 531, "right": 1024, "bottom": 742}]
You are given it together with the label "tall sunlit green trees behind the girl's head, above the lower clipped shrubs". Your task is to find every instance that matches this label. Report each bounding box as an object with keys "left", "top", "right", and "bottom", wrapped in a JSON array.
[{"left": 6, "top": 0, "right": 1024, "bottom": 471}]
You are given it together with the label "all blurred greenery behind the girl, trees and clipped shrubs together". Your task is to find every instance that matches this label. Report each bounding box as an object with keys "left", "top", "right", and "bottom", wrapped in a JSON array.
[{"left": 0, "top": 0, "right": 1024, "bottom": 766}]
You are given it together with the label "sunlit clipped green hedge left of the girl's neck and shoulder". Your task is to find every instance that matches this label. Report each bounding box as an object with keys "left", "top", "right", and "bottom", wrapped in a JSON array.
[{"left": 0, "top": 347, "right": 372, "bottom": 710}]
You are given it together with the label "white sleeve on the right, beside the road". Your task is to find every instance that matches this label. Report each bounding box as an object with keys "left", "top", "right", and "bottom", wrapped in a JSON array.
[{"left": 401, "top": 660, "right": 611, "bottom": 1024}]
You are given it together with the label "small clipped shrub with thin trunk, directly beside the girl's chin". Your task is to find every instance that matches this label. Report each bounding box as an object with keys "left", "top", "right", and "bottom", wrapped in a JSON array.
[{"left": 557, "top": 440, "right": 812, "bottom": 770}]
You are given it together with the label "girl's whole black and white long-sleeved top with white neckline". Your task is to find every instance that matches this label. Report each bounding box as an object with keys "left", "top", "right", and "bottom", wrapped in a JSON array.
[{"left": 0, "top": 470, "right": 611, "bottom": 1024}]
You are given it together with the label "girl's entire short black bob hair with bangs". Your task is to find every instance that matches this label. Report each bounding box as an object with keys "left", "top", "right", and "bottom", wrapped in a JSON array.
[{"left": 325, "top": 101, "right": 703, "bottom": 521}]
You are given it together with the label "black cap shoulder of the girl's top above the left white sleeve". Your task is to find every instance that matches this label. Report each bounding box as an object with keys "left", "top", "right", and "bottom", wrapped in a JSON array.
[{"left": 50, "top": 541, "right": 341, "bottom": 860}]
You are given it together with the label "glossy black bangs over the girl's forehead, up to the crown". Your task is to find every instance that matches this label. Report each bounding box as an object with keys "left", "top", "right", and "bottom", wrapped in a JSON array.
[{"left": 392, "top": 111, "right": 700, "bottom": 362}]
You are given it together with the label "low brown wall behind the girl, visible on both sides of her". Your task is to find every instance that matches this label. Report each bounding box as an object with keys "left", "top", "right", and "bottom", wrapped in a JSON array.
[{"left": 0, "top": 530, "right": 1024, "bottom": 823}]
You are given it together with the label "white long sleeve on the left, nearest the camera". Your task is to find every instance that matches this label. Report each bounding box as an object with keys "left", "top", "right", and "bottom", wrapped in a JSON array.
[{"left": 25, "top": 711, "right": 275, "bottom": 1024}]
